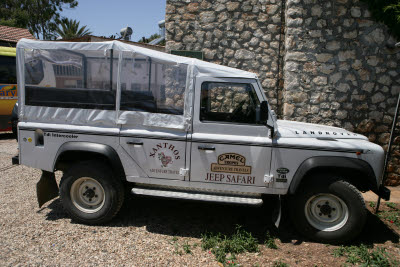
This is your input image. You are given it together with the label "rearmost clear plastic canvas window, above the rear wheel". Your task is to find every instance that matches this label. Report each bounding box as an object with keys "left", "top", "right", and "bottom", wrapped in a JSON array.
[{"left": 25, "top": 50, "right": 118, "bottom": 110}]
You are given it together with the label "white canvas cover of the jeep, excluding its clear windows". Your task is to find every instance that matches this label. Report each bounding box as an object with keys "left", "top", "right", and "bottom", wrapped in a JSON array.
[{"left": 17, "top": 39, "right": 257, "bottom": 130}]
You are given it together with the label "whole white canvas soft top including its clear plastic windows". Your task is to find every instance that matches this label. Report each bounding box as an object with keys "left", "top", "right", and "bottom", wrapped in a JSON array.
[{"left": 17, "top": 39, "right": 257, "bottom": 130}]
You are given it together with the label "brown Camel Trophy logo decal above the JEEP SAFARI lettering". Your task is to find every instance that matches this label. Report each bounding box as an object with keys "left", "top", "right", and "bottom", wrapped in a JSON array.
[{"left": 211, "top": 153, "right": 251, "bottom": 174}]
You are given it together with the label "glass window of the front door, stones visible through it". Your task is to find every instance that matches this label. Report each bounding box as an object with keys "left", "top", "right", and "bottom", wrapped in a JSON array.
[{"left": 200, "top": 82, "right": 260, "bottom": 124}]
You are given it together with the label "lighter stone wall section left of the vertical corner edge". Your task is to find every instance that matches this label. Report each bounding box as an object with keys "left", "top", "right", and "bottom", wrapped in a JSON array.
[{"left": 165, "top": 0, "right": 284, "bottom": 113}]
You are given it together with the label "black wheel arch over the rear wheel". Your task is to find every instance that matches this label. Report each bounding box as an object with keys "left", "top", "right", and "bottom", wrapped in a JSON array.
[{"left": 53, "top": 142, "right": 126, "bottom": 181}]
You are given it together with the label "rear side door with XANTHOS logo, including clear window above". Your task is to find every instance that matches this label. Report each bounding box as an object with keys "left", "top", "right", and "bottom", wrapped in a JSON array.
[{"left": 119, "top": 53, "right": 187, "bottom": 182}]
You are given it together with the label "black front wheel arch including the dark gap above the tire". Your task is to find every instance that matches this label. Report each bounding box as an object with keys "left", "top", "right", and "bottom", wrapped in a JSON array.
[{"left": 289, "top": 156, "right": 378, "bottom": 194}]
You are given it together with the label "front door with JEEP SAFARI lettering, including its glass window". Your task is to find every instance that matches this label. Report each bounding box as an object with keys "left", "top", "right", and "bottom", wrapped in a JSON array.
[{"left": 190, "top": 78, "right": 272, "bottom": 190}]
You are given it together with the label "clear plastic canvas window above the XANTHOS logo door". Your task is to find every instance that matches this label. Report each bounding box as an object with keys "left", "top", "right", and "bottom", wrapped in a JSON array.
[{"left": 120, "top": 53, "right": 188, "bottom": 115}]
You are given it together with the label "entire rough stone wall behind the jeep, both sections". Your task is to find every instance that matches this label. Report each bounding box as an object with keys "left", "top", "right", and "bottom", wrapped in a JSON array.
[{"left": 166, "top": 0, "right": 400, "bottom": 184}]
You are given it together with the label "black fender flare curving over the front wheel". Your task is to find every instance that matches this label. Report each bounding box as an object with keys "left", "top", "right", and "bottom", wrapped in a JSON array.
[{"left": 289, "top": 156, "right": 378, "bottom": 194}]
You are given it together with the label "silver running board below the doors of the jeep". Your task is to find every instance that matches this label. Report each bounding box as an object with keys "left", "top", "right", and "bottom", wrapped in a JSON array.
[{"left": 131, "top": 188, "right": 263, "bottom": 205}]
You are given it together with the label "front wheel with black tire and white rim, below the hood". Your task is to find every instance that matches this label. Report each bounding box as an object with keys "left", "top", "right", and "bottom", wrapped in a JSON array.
[{"left": 290, "top": 177, "right": 367, "bottom": 244}]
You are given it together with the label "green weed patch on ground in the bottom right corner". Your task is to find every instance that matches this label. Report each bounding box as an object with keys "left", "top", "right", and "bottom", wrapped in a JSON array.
[{"left": 333, "top": 244, "right": 398, "bottom": 267}]
